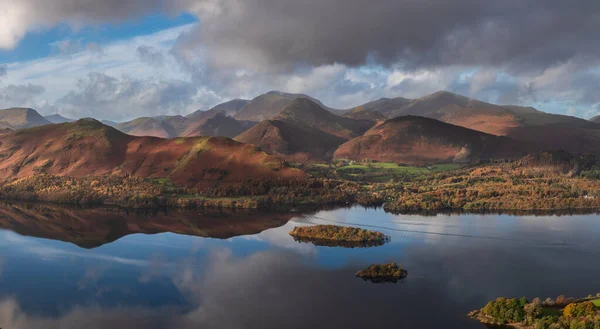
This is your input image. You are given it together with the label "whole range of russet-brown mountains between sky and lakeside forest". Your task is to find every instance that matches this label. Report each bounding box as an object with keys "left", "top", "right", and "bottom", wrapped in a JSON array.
[{"left": 0, "top": 91, "right": 600, "bottom": 173}]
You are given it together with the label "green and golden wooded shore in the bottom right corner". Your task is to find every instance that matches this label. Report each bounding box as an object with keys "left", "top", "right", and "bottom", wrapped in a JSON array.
[{"left": 468, "top": 294, "right": 600, "bottom": 329}]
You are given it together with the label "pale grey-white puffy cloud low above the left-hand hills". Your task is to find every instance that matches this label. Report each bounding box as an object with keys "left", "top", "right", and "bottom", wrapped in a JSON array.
[{"left": 56, "top": 72, "right": 204, "bottom": 120}]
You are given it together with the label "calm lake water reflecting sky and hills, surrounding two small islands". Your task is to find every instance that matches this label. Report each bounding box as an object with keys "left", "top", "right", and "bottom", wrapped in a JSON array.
[{"left": 0, "top": 204, "right": 600, "bottom": 329}]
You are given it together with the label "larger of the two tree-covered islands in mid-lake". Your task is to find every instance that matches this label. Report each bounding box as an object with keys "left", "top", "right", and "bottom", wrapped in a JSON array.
[{"left": 290, "top": 225, "right": 388, "bottom": 248}]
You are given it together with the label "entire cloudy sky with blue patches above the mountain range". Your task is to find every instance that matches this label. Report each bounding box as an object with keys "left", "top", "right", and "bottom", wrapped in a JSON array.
[{"left": 0, "top": 0, "right": 600, "bottom": 121}]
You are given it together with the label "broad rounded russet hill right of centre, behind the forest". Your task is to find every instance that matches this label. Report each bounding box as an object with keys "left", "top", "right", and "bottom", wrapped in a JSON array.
[{"left": 334, "top": 116, "right": 530, "bottom": 165}]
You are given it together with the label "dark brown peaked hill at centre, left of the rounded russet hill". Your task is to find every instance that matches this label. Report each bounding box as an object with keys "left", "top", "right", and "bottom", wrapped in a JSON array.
[{"left": 235, "top": 98, "right": 375, "bottom": 161}]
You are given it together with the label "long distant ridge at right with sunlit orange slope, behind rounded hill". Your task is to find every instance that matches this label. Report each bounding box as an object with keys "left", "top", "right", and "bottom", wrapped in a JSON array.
[{"left": 346, "top": 91, "right": 600, "bottom": 152}]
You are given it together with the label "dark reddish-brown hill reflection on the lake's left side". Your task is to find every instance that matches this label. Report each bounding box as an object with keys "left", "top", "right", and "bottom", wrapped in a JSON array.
[{"left": 0, "top": 203, "right": 293, "bottom": 248}]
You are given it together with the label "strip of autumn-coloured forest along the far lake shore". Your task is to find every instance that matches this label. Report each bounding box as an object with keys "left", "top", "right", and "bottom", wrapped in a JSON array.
[{"left": 0, "top": 153, "right": 600, "bottom": 213}]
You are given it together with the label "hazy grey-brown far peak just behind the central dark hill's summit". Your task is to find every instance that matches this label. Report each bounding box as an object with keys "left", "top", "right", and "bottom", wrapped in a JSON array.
[{"left": 234, "top": 91, "right": 330, "bottom": 122}]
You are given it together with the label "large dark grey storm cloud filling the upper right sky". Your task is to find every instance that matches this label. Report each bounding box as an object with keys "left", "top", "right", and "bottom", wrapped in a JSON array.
[{"left": 188, "top": 0, "right": 600, "bottom": 69}]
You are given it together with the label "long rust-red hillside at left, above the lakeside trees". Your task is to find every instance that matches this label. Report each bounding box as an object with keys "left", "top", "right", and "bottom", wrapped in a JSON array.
[{"left": 0, "top": 119, "right": 303, "bottom": 189}]
